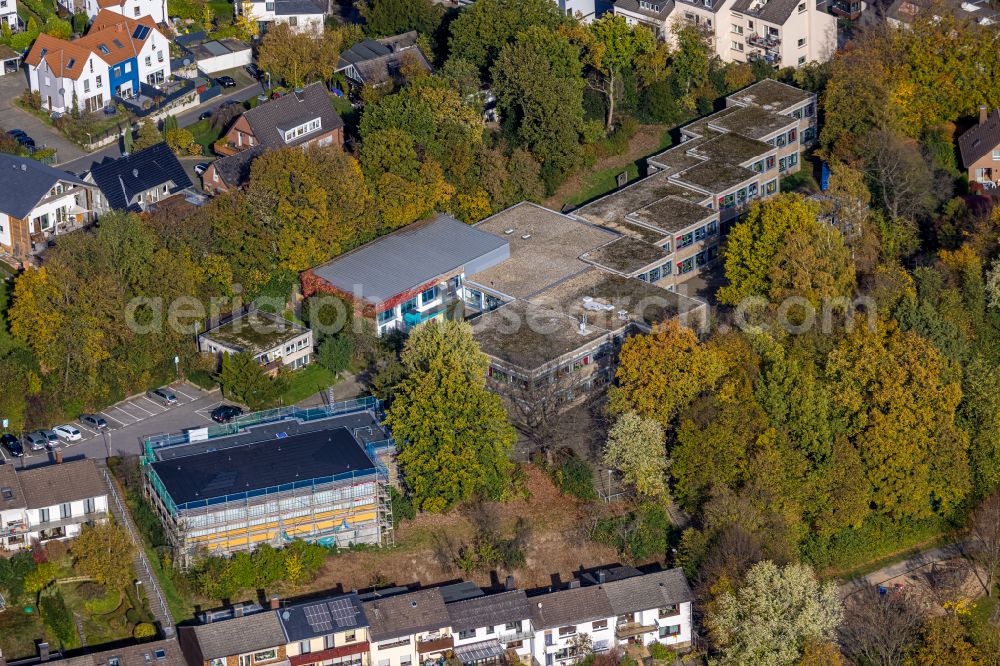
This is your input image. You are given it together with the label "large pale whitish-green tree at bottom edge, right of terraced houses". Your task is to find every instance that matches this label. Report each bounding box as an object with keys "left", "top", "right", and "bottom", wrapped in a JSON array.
[{"left": 707, "top": 561, "right": 843, "bottom": 666}]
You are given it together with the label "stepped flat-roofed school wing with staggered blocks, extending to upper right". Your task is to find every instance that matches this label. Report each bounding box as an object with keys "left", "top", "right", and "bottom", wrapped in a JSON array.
[{"left": 569, "top": 80, "right": 817, "bottom": 290}]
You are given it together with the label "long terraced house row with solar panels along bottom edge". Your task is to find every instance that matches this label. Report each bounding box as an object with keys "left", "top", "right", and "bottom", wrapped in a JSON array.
[{"left": 178, "top": 567, "right": 693, "bottom": 666}]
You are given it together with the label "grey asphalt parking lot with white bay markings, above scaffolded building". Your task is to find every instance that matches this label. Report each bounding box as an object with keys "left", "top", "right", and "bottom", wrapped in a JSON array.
[{"left": 0, "top": 382, "right": 237, "bottom": 467}]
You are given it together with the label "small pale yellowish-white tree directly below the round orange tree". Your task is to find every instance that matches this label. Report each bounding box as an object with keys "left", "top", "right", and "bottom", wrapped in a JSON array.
[{"left": 604, "top": 411, "right": 667, "bottom": 499}]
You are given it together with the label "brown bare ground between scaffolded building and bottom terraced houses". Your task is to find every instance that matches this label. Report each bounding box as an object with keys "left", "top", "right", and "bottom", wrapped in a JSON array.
[{"left": 299, "top": 465, "right": 618, "bottom": 594}]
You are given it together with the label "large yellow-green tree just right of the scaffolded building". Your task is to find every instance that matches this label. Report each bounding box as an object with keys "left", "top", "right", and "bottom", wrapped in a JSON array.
[{"left": 386, "top": 321, "right": 517, "bottom": 512}]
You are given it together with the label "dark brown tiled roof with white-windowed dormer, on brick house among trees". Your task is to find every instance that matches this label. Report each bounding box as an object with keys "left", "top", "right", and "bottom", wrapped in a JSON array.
[{"left": 243, "top": 83, "right": 344, "bottom": 148}]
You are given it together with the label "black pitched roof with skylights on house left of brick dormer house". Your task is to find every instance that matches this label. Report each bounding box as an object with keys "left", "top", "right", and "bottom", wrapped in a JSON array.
[{"left": 90, "top": 143, "right": 191, "bottom": 210}]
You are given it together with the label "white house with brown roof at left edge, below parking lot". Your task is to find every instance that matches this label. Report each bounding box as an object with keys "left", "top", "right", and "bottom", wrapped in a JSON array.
[{"left": 0, "top": 459, "right": 108, "bottom": 550}]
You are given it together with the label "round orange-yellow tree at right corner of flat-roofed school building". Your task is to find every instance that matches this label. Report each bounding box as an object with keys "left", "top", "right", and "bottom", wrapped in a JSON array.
[{"left": 608, "top": 320, "right": 726, "bottom": 427}]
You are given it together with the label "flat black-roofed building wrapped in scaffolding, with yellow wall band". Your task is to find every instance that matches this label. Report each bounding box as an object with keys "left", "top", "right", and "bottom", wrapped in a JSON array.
[{"left": 142, "top": 398, "right": 395, "bottom": 568}]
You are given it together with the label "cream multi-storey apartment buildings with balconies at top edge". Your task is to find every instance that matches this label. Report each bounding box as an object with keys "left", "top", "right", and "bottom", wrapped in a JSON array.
[{"left": 614, "top": 0, "right": 837, "bottom": 68}]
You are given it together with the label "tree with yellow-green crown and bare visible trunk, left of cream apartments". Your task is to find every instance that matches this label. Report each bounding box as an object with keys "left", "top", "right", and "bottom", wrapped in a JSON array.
[{"left": 587, "top": 14, "right": 656, "bottom": 133}]
